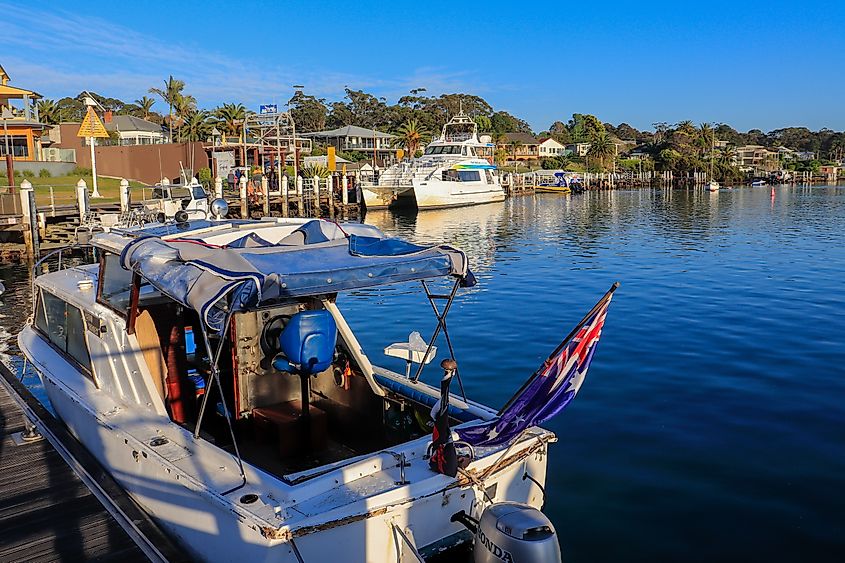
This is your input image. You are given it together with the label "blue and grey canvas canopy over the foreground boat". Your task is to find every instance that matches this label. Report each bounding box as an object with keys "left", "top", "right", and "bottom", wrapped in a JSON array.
[{"left": 113, "top": 221, "right": 475, "bottom": 331}]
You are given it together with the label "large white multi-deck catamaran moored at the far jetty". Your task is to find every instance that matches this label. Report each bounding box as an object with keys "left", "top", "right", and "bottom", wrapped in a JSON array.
[{"left": 361, "top": 112, "right": 505, "bottom": 209}]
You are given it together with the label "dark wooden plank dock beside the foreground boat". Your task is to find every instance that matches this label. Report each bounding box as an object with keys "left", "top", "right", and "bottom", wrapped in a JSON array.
[{"left": 0, "top": 365, "right": 186, "bottom": 563}]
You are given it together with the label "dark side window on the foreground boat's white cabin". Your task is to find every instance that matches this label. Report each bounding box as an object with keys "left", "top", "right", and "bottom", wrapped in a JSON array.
[{"left": 35, "top": 291, "right": 91, "bottom": 372}]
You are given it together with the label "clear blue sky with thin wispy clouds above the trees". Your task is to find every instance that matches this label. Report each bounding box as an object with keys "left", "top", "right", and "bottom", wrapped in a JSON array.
[{"left": 0, "top": 0, "right": 845, "bottom": 131}]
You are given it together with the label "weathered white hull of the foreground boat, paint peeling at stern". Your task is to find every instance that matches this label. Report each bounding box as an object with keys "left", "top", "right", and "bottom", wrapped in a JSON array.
[{"left": 20, "top": 330, "right": 548, "bottom": 563}]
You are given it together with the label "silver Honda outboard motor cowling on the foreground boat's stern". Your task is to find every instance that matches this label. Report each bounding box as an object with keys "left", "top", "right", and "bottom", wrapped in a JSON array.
[{"left": 472, "top": 502, "right": 561, "bottom": 563}]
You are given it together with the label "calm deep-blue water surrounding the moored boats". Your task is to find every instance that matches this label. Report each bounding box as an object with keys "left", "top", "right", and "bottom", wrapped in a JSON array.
[{"left": 0, "top": 187, "right": 845, "bottom": 561}]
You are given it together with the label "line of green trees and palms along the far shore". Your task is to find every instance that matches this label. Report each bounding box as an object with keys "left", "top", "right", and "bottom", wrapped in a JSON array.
[{"left": 38, "top": 76, "right": 845, "bottom": 177}]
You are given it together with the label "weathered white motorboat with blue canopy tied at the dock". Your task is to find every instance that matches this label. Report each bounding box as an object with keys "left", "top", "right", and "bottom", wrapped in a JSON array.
[{"left": 18, "top": 213, "right": 609, "bottom": 563}]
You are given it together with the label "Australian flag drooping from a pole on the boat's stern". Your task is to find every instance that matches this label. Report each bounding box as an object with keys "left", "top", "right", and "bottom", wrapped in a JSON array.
[{"left": 456, "top": 283, "right": 619, "bottom": 446}]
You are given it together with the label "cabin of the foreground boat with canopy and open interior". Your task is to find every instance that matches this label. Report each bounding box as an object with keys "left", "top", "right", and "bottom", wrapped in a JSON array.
[{"left": 34, "top": 219, "right": 492, "bottom": 480}]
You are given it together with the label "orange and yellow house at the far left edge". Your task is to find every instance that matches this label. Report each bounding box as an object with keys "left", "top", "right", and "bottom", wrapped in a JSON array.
[{"left": 0, "top": 66, "right": 50, "bottom": 161}]
